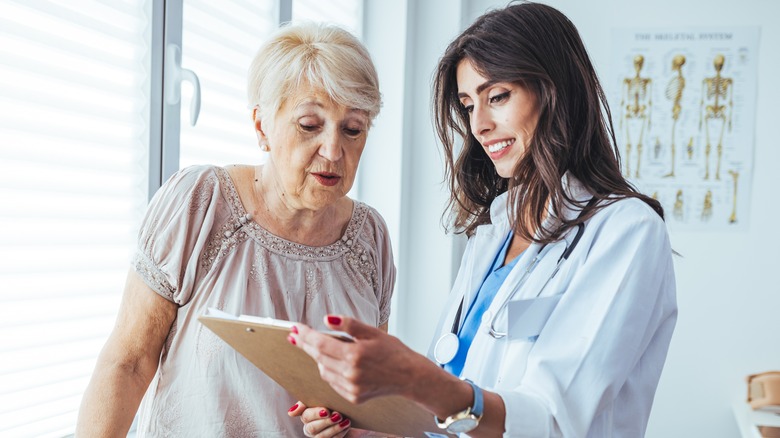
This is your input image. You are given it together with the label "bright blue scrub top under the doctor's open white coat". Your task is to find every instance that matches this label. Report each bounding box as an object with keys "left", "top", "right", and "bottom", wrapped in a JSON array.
[{"left": 444, "top": 232, "right": 520, "bottom": 377}]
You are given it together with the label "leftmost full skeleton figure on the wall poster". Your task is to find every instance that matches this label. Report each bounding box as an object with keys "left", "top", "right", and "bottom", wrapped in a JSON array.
[{"left": 620, "top": 55, "right": 653, "bottom": 178}]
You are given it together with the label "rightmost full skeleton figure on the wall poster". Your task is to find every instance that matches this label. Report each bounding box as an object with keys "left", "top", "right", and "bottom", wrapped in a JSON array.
[{"left": 699, "top": 55, "right": 734, "bottom": 180}]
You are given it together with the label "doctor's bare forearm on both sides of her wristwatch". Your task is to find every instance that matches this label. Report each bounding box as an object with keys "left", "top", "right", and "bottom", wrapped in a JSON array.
[{"left": 407, "top": 359, "right": 506, "bottom": 438}]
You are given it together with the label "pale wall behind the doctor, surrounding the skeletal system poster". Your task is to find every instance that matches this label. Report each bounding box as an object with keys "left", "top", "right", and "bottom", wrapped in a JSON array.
[{"left": 402, "top": 0, "right": 780, "bottom": 438}]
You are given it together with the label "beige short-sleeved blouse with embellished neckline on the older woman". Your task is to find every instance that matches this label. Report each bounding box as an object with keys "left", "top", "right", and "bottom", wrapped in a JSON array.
[{"left": 134, "top": 166, "right": 395, "bottom": 437}]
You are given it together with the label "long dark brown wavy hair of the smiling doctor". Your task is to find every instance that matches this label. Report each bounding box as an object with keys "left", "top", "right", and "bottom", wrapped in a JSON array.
[{"left": 433, "top": 2, "right": 663, "bottom": 243}]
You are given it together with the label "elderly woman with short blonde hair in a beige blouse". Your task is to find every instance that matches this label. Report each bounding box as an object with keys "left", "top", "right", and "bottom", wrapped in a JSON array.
[{"left": 77, "top": 24, "right": 395, "bottom": 437}]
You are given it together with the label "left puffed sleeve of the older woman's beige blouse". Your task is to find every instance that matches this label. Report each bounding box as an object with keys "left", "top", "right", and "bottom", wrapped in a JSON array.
[{"left": 133, "top": 166, "right": 219, "bottom": 306}]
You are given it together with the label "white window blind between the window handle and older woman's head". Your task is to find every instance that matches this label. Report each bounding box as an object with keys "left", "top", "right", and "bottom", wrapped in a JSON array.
[{"left": 179, "top": 0, "right": 278, "bottom": 167}]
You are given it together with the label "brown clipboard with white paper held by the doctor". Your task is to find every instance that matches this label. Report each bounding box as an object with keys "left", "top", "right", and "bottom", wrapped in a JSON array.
[{"left": 198, "top": 315, "right": 451, "bottom": 437}]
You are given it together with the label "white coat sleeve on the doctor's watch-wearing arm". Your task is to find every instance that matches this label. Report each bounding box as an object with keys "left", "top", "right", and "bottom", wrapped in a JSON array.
[{"left": 497, "top": 200, "right": 677, "bottom": 437}]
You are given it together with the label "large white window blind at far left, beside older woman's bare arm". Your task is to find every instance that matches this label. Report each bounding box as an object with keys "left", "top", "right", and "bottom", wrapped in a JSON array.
[{"left": 0, "top": 0, "right": 151, "bottom": 437}]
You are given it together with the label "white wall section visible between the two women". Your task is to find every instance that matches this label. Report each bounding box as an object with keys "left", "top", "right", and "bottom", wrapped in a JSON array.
[{"left": 359, "top": 0, "right": 470, "bottom": 352}]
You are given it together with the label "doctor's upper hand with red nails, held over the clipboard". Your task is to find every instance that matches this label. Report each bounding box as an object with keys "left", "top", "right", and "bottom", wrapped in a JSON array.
[{"left": 289, "top": 315, "right": 435, "bottom": 403}]
